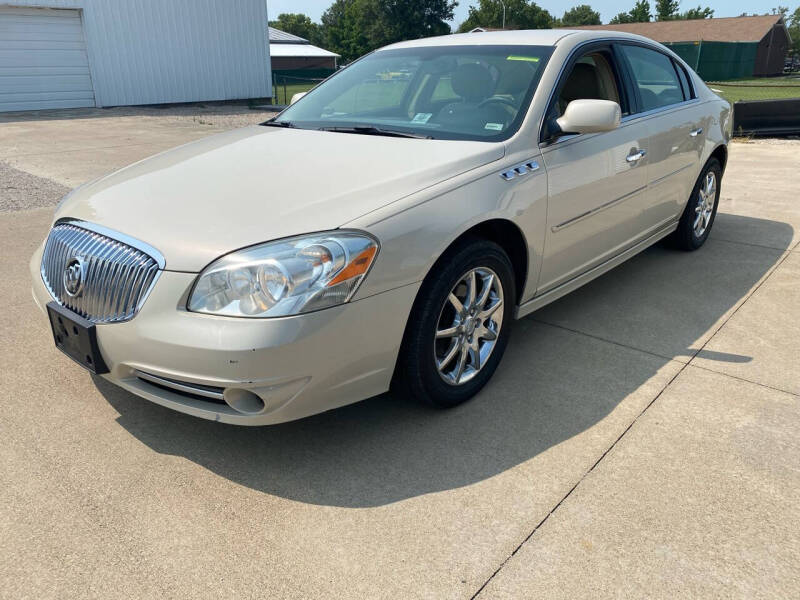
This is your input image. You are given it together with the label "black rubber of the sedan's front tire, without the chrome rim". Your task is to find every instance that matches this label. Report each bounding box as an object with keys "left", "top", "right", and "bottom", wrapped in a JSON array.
[{"left": 395, "top": 240, "right": 516, "bottom": 407}]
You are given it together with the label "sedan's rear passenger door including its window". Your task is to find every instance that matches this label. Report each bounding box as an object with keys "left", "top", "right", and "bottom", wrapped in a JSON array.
[{"left": 620, "top": 43, "right": 709, "bottom": 234}]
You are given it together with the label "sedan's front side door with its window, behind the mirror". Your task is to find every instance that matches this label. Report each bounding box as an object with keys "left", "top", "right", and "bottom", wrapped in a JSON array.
[{"left": 537, "top": 44, "right": 648, "bottom": 293}]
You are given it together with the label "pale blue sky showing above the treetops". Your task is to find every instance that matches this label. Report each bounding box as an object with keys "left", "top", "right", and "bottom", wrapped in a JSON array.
[{"left": 267, "top": 0, "right": 776, "bottom": 26}]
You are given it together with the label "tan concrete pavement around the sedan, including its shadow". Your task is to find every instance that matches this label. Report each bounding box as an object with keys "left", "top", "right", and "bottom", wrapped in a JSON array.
[{"left": 0, "top": 109, "right": 800, "bottom": 598}]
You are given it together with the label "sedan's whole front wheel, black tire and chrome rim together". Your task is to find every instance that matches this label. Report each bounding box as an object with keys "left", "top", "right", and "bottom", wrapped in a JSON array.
[{"left": 392, "top": 238, "right": 516, "bottom": 408}]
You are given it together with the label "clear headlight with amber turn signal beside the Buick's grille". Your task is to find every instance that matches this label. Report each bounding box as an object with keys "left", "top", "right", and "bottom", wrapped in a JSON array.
[{"left": 188, "top": 231, "right": 378, "bottom": 317}]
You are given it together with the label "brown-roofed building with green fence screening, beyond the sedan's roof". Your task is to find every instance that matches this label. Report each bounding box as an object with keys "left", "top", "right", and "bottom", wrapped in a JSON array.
[{"left": 571, "top": 15, "right": 791, "bottom": 81}]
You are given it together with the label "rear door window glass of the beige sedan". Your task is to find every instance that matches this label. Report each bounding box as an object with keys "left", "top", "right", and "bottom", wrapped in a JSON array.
[{"left": 622, "top": 46, "right": 684, "bottom": 112}]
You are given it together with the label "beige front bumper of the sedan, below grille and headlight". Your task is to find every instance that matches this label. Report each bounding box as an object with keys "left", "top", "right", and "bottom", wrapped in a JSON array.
[{"left": 30, "top": 248, "right": 419, "bottom": 425}]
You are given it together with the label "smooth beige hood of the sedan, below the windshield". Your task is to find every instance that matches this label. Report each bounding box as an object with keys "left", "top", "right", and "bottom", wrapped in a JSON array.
[{"left": 56, "top": 126, "right": 503, "bottom": 272}]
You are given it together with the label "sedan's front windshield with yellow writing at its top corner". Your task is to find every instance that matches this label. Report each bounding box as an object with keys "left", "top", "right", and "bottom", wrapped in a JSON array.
[{"left": 272, "top": 45, "right": 552, "bottom": 141}]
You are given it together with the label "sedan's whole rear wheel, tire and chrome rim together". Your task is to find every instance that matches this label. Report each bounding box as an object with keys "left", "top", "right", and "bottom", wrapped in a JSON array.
[{"left": 671, "top": 158, "right": 722, "bottom": 252}]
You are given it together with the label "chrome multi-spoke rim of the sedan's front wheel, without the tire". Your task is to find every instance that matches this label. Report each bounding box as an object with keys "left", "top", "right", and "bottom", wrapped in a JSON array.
[{"left": 434, "top": 267, "right": 503, "bottom": 385}]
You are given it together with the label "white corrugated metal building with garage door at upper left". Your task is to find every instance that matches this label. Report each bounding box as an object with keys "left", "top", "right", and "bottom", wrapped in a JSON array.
[{"left": 0, "top": 0, "right": 272, "bottom": 111}]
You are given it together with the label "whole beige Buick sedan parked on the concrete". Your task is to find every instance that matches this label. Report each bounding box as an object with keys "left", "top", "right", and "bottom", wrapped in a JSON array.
[{"left": 30, "top": 30, "right": 731, "bottom": 425}]
